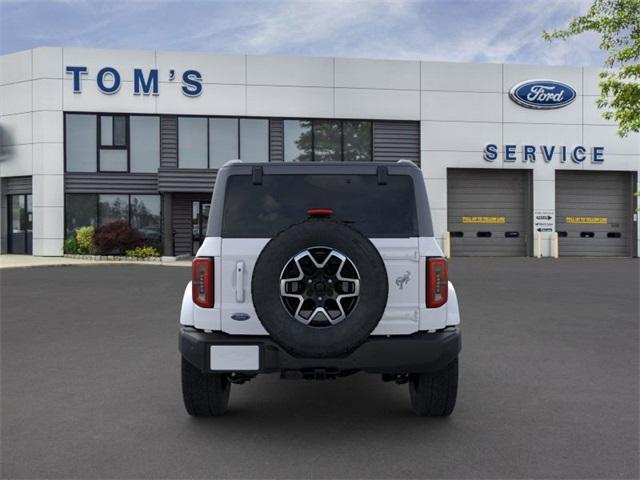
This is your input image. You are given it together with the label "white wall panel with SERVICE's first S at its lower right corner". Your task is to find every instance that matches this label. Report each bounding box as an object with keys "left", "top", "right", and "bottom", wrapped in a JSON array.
[{"left": 420, "top": 121, "right": 502, "bottom": 151}]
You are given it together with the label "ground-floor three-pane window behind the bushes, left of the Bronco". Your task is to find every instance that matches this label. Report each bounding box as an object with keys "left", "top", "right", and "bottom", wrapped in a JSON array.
[{"left": 65, "top": 193, "right": 162, "bottom": 242}]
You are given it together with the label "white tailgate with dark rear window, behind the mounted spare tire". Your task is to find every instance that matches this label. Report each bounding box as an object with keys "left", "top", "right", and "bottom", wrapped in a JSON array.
[{"left": 220, "top": 174, "right": 420, "bottom": 335}]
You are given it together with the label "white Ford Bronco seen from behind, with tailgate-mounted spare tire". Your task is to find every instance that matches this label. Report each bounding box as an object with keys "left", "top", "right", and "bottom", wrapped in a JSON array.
[{"left": 180, "top": 160, "right": 461, "bottom": 416}]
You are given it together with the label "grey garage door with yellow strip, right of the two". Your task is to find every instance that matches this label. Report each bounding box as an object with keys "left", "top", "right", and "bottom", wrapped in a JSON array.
[{"left": 556, "top": 171, "right": 633, "bottom": 257}]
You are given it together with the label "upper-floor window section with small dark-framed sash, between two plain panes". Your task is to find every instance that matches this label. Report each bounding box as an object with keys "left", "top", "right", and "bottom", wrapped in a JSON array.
[{"left": 99, "top": 115, "right": 128, "bottom": 172}]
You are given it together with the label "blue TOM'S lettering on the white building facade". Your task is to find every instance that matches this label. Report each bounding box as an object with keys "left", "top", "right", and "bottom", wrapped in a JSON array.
[{"left": 65, "top": 65, "right": 202, "bottom": 97}]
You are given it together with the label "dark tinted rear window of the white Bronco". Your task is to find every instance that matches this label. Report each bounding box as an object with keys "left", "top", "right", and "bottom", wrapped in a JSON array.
[{"left": 222, "top": 175, "right": 418, "bottom": 238}]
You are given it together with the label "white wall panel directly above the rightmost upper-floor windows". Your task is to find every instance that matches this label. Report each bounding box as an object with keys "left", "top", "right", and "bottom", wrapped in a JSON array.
[{"left": 335, "top": 88, "right": 420, "bottom": 120}]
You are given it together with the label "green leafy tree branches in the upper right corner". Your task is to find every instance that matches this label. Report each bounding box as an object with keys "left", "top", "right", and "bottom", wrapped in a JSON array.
[{"left": 543, "top": 0, "right": 640, "bottom": 136}]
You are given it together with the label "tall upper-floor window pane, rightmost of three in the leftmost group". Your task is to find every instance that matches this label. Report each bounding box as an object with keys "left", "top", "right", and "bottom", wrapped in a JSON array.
[{"left": 129, "top": 115, "right": 160, "bottom": 173}]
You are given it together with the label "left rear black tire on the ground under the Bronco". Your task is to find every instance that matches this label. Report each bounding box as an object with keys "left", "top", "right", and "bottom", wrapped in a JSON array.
[{"left": 182, "top": 357, "right": 231, "bottom": 417}]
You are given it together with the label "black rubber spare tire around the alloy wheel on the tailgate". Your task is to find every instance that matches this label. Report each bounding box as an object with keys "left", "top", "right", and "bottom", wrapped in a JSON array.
[{"left": 251, "top": 219, "right": 389, "bottom": 358}]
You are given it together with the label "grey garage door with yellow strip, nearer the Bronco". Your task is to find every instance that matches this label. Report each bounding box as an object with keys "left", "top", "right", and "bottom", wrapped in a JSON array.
[{"left": 447, "top": 169, "right": 531, "bottom": 257}]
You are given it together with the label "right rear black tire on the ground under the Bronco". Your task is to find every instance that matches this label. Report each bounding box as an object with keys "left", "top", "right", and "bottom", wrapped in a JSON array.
[{"left": 409, "top": 357, "right": 458, "bottom": 417}]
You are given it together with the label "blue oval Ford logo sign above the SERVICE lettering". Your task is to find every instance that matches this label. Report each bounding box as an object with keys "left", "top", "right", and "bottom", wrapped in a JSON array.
[{"left": 509, "top": 80, "right": 576, "bottom": 110}]
